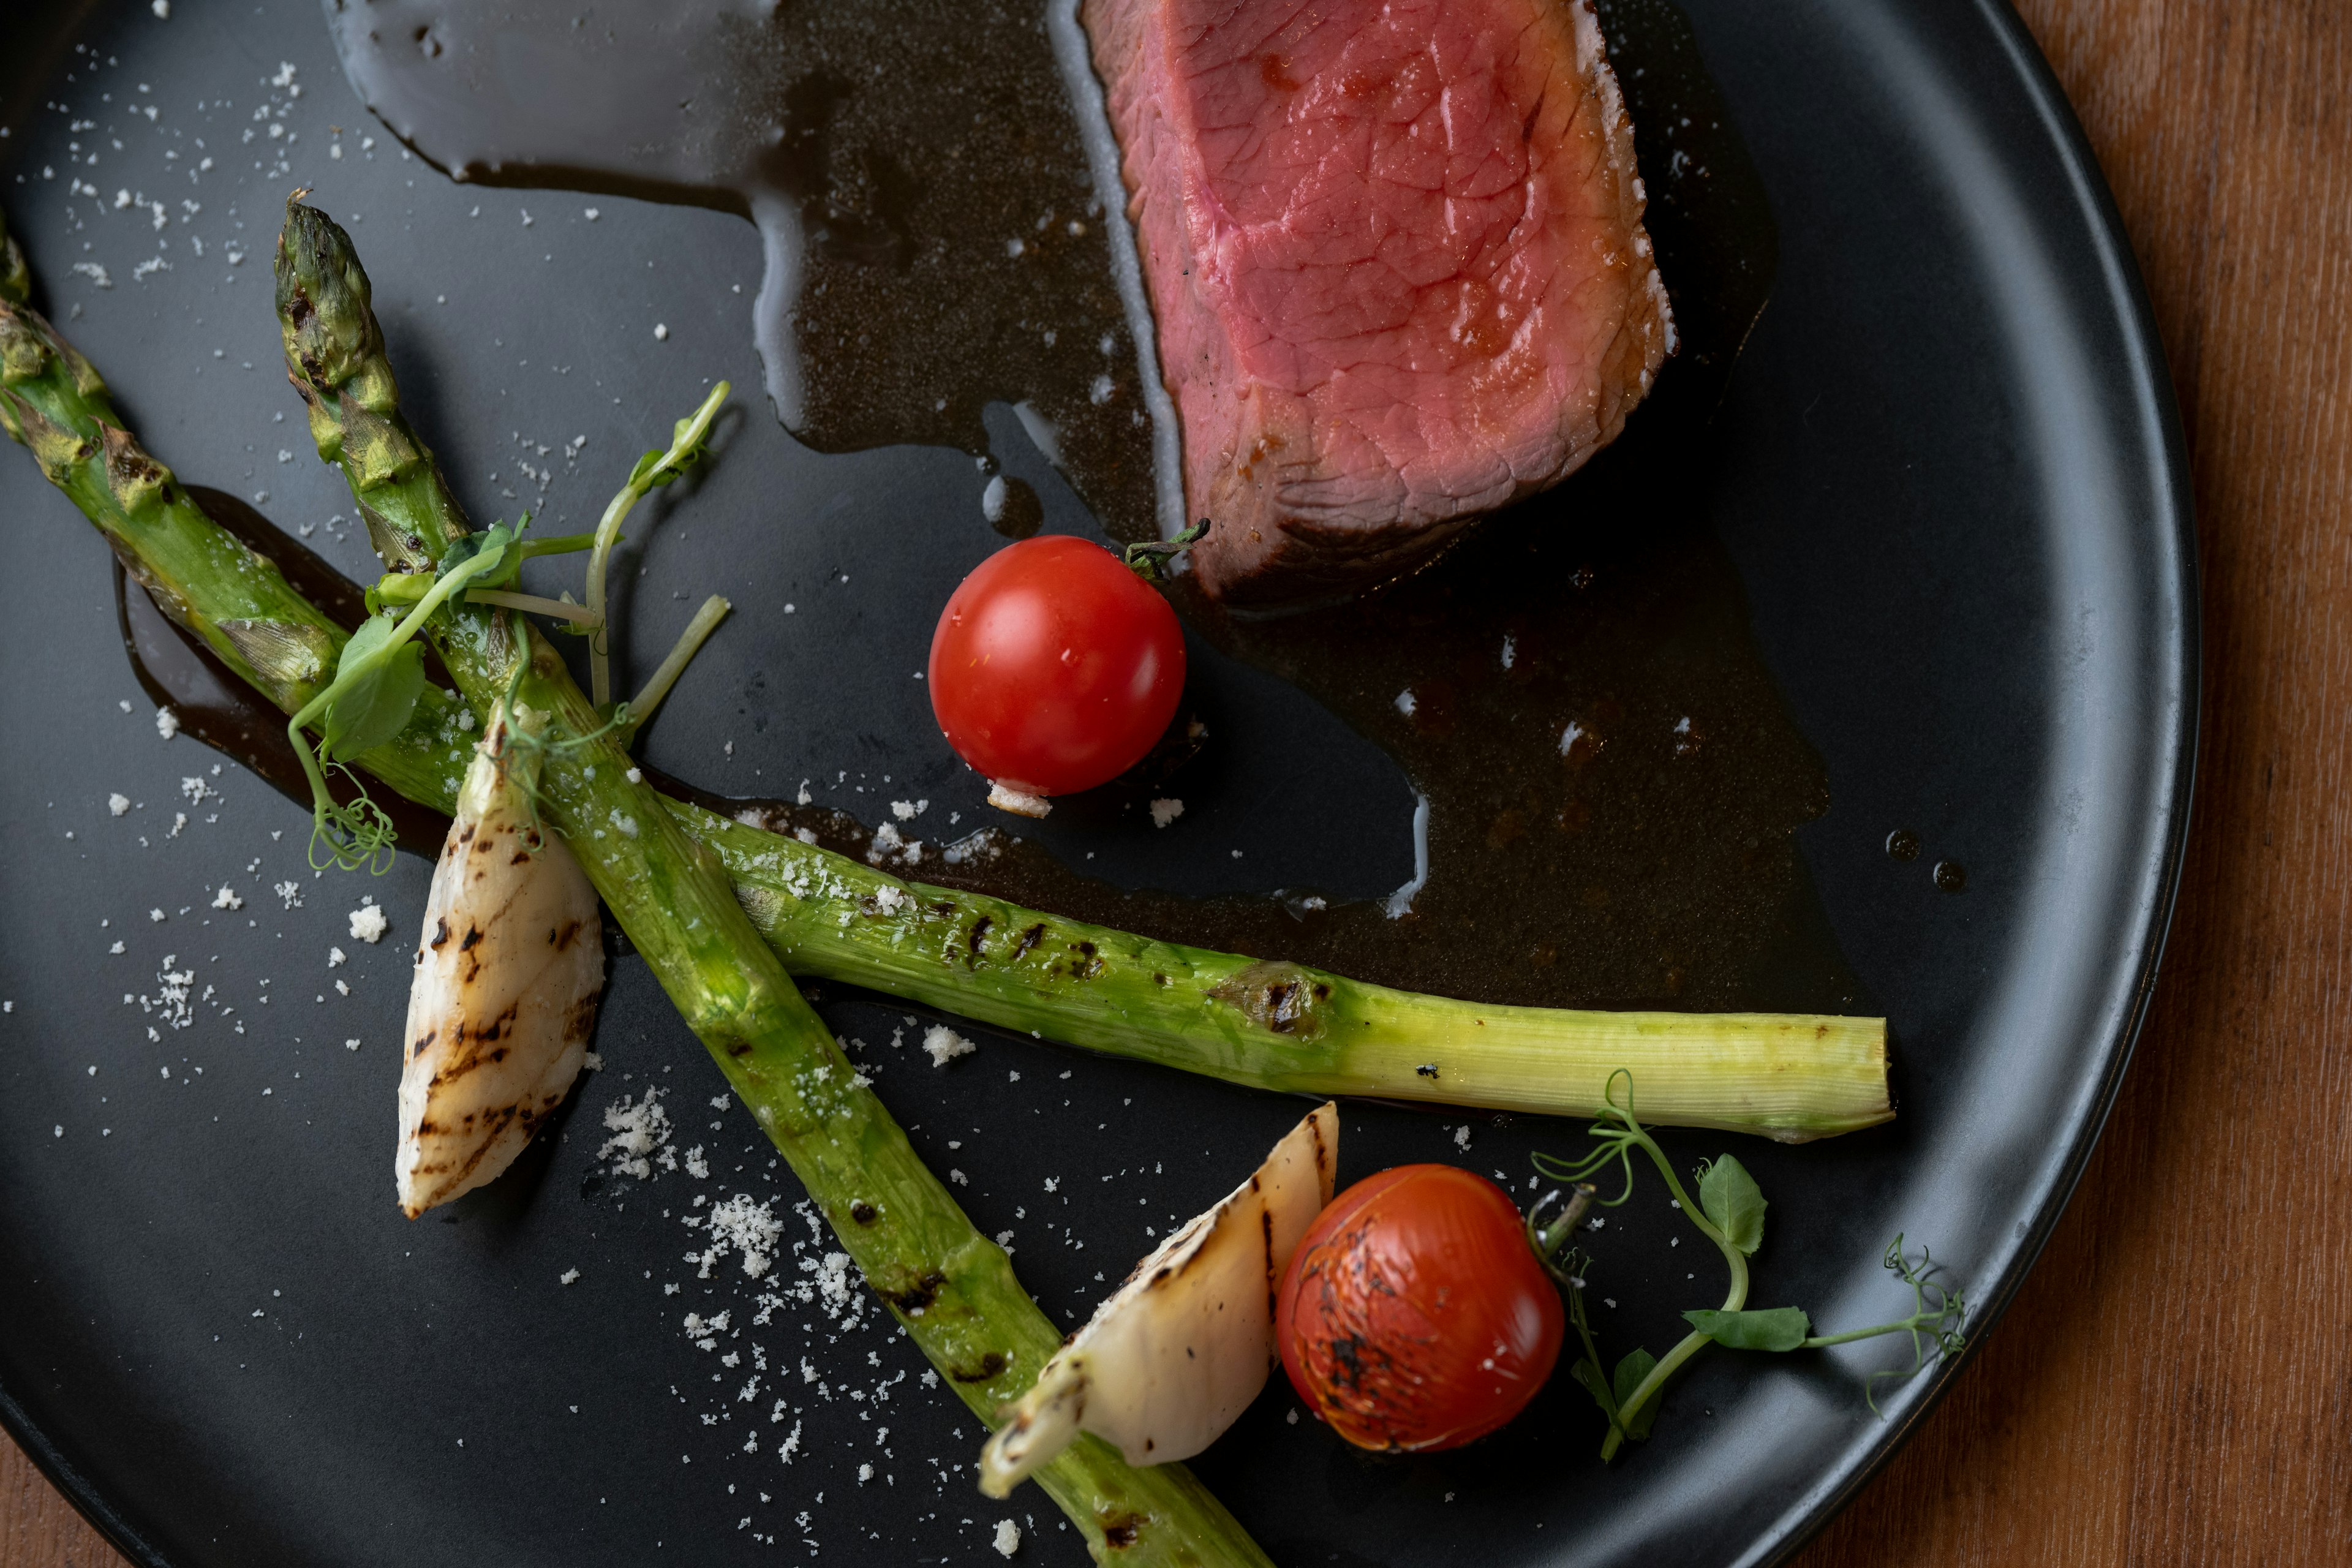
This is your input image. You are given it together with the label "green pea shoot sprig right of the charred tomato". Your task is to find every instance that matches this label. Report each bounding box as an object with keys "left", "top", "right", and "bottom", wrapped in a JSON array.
[{"left": 1529, "top": 1072, "right": 1969, "bottom": 1462}]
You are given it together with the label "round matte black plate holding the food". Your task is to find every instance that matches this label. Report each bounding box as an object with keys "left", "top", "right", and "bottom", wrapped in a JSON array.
[{"left": 0, "top": 0, "right": 2197, "bottom": 1568}]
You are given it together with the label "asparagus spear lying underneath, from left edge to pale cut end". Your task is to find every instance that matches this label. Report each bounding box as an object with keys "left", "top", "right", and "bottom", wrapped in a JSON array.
[{"left": 0, "top": 196, "right": 1893, "bottom": 1142}]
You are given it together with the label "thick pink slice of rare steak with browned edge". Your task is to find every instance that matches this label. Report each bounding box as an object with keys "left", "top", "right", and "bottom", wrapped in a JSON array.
[{"left": 1084, "top": 0, "right": 1675, "bottom": 606}]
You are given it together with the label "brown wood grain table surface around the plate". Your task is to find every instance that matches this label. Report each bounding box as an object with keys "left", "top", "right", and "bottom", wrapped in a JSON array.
[{"left": 0, "top": 0, "right": 2352, "bottom": 1568}]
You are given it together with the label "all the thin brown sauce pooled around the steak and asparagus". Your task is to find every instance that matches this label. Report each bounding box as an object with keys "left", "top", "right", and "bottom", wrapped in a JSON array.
[{"left": 125, "top": 0, "right": 1863, "bottom": 1011}]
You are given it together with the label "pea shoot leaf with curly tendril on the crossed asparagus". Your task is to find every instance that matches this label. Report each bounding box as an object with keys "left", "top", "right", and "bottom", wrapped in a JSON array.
[{"left": 287, "top": 524, "right": 520, "bottom": 875}]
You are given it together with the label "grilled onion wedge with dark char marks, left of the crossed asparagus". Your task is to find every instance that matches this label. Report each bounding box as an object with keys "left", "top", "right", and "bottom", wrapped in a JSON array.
[{"left": 393, "top": 705, "right": 605, "bottom": 1220}]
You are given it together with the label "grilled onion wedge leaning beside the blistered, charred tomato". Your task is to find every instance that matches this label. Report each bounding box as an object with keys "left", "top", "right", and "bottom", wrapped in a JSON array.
[{"left": 981, "top": 1102, "right": 1338, "bottom": 1498}]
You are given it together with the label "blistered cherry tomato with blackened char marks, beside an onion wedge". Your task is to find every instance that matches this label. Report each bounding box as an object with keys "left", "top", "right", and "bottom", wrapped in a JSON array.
[{"left": 1275, "top": 1166, "right": 1564, "bottom": 1450}]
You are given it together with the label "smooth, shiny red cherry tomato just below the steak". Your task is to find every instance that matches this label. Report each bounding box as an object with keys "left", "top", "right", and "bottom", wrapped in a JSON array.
[{"left": 929, "top": 533, "right": 1183, "bottom": 794}]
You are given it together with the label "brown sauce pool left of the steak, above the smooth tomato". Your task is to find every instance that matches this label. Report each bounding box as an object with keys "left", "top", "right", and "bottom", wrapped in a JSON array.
[{"left": 330, "top": 0, "right": 1157, "bottom": 538}]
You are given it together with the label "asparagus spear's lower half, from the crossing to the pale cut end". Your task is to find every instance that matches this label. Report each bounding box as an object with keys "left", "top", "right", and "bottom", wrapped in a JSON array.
[{"left": 715, "top": 832, "right": 1893, "bottom": 1142}]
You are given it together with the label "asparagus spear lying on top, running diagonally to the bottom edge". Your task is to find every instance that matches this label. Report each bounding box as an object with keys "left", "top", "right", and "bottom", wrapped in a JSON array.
[{"left": 277, "top": 202, "right": 1265, "bottom": 1563}]
